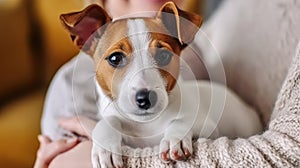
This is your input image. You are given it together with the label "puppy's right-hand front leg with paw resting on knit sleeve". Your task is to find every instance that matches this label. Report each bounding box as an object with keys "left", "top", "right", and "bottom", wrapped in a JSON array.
[{"left": 159, "top": 120, "right": 193, "bottom": 162}]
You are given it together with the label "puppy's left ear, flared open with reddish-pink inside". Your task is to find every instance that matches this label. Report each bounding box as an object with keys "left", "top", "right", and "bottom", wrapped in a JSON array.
[{"left": 60, "top": 4, "right": 112, "bottom": 54}]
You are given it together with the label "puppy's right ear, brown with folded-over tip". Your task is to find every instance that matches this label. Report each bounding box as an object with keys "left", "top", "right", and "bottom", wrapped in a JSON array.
[{"left": 157, "top": 2, "right": 202, "bottom": 46}]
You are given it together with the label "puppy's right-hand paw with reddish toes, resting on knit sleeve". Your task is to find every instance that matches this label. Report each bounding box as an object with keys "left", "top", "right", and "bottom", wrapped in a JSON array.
[{"left": 159, "top": 137, "right": 193, "bottom": 162}]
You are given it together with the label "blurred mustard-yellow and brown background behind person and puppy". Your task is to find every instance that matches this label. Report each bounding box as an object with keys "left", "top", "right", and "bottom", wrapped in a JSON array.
[{"left": 0, "top": 0, "right": 220, "bottom": 168}]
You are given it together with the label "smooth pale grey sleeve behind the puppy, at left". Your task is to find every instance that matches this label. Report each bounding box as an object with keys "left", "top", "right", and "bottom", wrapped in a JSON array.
[{"left": 41, "top": 52, "right": 97, "bottom": 140}]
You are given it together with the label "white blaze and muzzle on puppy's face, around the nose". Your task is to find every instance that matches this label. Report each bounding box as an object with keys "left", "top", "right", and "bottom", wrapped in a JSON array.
[{"left": 117, "top": 19, "right": 168, "bottom": 121}]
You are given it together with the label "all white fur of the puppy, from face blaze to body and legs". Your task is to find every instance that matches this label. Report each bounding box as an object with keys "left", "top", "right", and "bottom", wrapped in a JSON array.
[{"left": 92, "top": 19, "right": 261, "bottom": 167}]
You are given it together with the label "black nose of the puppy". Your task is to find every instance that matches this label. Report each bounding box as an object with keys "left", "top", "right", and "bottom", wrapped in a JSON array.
[{"left": 135, "top": 89, "right": 157, "bottom": 110}]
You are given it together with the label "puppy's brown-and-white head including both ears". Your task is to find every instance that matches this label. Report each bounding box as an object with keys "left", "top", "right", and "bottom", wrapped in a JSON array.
[{"left": 61, "top": 2, "right": 202, "bottom": 121}]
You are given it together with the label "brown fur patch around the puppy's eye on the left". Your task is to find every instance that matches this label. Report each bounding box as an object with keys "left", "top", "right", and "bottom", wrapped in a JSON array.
[{"left": 93, "top": 20, "right": 133, "bottom": 99}]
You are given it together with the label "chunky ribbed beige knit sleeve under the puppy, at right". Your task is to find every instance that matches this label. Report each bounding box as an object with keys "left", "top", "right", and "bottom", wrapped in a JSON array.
[{"left": 123, "top": 43, "right": 300, "bottom": 167}]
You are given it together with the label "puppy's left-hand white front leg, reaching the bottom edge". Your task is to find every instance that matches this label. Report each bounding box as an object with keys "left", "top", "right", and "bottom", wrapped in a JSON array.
[{"left": 92, "top": 116, "right": 123, "bottom": 168}]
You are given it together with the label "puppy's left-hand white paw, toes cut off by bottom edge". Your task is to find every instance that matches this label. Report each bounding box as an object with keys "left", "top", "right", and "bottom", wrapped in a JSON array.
[{"left": 92, "top": 143, "right": 123, "bottom": 168}]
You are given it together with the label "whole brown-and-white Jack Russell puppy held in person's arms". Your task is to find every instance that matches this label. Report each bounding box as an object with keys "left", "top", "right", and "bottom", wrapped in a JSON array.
[{"left": 61, "top": 2, "right": 261, "bottom": 167}]
